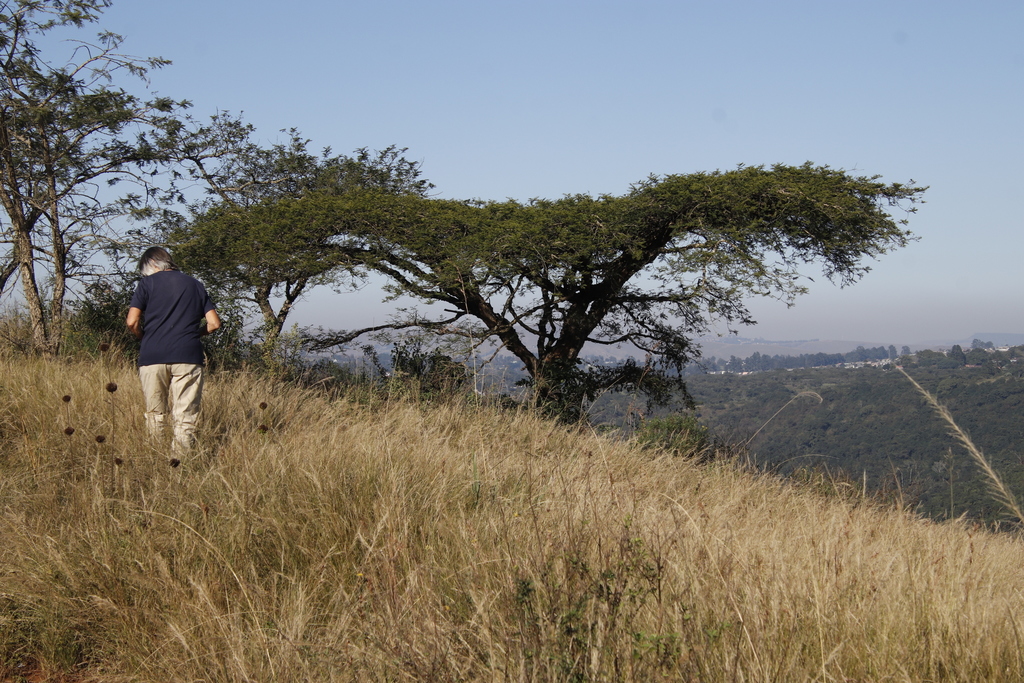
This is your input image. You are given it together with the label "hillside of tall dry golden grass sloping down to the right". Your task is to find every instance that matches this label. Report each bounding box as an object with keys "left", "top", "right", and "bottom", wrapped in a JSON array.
[{"left": 0, "top": 358, "right": 1024, "bottom": 682}]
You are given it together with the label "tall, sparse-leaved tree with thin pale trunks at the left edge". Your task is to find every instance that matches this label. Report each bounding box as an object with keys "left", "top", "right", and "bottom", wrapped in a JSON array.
[{"left": 0, "top": 0, "right": 179, "bottom": 353}]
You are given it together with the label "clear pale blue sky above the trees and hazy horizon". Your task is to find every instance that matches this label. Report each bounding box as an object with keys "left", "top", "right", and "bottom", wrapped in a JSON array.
[{"left": 101, "top": 0, "right": 1024, "bottom": 344}]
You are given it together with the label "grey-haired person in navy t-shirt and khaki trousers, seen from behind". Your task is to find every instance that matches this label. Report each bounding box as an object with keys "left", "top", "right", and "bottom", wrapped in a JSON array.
[{"left": 125, "top": 247, "right": 220, "bottom": 455}]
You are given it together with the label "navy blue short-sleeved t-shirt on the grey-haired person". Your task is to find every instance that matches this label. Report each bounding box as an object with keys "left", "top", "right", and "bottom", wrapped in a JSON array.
[{"left": 129, "top": 270, "right": 214, "bottom": 366}]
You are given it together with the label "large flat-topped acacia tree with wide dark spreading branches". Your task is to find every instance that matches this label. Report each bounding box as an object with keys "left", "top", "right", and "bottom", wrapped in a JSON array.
[{"left": 317, "top": 164, "right": 925, "bottom": 411}]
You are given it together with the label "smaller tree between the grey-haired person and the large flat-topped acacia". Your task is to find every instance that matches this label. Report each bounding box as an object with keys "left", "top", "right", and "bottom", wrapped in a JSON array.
[{"left": 162, "top": 115, "right": 433, "bottom": 346}]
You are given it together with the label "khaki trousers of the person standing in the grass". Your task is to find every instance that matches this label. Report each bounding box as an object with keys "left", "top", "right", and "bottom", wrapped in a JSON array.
[{"left": 138, "top": 362, "right": 203, "bottom": 455}]
